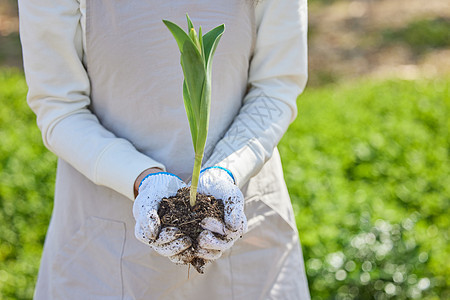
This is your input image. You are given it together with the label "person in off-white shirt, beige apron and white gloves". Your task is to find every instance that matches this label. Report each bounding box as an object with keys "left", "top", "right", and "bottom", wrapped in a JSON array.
[{"left": 19, "top": 0, "right": 309, "bottom": 300}]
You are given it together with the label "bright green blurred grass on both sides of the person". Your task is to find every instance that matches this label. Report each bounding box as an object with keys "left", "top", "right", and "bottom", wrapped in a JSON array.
[{"left": 0, "top": 71, "right": 450, "bottom": 299}]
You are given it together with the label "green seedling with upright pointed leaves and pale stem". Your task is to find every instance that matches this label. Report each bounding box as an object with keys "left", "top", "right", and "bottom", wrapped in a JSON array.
[{"left": 163, "top": 14, "right": 225, "bottom": 206}]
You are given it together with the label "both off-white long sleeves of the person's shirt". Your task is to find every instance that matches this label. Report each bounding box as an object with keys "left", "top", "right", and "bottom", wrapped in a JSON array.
[{"left": 19, "top": 0, "right": 307, "bottom": 199}]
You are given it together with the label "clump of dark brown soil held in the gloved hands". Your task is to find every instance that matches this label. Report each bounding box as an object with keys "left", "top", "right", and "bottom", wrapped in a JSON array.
[{"left": 158, "top": 187, "right": 225, "bottom": 273}]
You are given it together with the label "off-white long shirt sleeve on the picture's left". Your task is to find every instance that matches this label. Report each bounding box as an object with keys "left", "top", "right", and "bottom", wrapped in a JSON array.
[{"left": 19, "top": 0, "right": 164, "bottom": 199}]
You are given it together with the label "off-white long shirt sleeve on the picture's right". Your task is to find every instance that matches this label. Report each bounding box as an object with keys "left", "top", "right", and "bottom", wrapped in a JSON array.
[{"left": 205, "top": 0, "right": 307, "bottom": 187}]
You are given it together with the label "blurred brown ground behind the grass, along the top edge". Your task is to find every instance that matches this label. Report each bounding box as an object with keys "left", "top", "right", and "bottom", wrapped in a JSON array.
[{"left": 0, "top": 0, "right": 450, "bottom": 86}]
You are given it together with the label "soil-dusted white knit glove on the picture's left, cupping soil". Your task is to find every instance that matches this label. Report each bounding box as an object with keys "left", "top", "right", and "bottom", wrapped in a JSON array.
[{"left": 133, "top": 172, "right": 192, "bottom": 257}]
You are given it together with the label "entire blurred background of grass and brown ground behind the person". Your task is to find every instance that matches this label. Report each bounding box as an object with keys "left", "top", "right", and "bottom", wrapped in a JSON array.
[{"left": 0, "top": 0, "right": 450, "bottom": 300}]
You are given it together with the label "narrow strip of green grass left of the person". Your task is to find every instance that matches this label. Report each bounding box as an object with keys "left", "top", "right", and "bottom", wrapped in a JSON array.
[{"left": 0, "top": 70, "right": 56, "bottom": 299}]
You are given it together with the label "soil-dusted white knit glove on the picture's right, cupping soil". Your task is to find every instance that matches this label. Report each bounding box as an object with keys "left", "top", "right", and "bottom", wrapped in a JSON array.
[{"left": 196, "top": 167, "right": 247, "bottom": 260}]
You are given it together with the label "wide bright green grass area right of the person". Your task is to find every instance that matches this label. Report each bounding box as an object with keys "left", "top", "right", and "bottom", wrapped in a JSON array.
[{"left": 280, "top": 79, "right": 450, "bottom": 299}]
